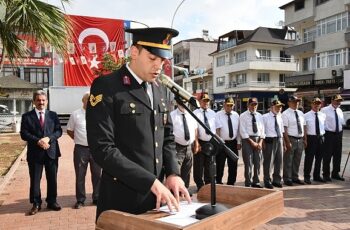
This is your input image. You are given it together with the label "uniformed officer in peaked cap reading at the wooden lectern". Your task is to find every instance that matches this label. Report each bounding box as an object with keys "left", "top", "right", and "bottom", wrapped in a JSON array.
[{"left": 86, "top": 28, "right": 190, "bottom": 218}]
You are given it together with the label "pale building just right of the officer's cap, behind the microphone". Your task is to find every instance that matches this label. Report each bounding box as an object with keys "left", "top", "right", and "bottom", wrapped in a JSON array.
[{"left": 174, "top": 30, "right": 217, "bottom": 97}]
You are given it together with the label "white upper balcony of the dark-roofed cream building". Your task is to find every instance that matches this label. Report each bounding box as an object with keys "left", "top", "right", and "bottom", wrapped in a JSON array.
[{"left": 225, "top": 57, "right": 297, "bottom": 73}]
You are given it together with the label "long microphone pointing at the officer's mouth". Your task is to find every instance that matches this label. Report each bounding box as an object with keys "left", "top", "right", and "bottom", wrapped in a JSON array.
[{"left": 158, "top": 73, "right": 199, "bottom": 109}]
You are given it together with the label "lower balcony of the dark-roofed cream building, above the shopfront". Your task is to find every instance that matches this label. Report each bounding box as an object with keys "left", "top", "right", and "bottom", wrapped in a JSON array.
[{"left": 225, "top": 81, "right": 293, "bottom": 93}]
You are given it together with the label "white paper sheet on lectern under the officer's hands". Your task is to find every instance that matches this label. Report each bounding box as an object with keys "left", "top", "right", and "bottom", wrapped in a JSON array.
[{"left": 157, "top": 201, "right": 208, "bottom": 226}]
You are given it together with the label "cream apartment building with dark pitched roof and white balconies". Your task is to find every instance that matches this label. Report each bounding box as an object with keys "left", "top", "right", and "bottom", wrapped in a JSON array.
[{"left": 211, "top": 27, "right": 296, "bottom": 112}]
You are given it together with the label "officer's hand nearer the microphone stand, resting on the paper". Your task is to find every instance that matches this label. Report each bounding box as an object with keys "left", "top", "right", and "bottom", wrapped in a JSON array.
[{"left": 165, "top": 175, "right": 191, "bottom": 203}]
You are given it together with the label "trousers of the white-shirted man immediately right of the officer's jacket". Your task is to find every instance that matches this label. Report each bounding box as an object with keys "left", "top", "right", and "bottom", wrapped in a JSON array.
[{"left": 176, "top": 143, "right": 192, "bottom": 188}]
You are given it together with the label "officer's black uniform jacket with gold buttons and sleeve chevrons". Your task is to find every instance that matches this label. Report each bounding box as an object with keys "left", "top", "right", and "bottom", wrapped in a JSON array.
[{"left": 86, "top": 66, "right": 180, "bottom": 217}]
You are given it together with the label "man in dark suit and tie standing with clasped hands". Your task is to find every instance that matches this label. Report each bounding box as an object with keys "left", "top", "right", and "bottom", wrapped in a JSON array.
[{"left": 21, "top": 90, "right": 62, "bottom": 215}]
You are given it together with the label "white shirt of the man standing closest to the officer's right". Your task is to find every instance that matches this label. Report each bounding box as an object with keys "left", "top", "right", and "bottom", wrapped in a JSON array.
[{"left": 170, "top": 109, "right": 198, "bottom": 145}]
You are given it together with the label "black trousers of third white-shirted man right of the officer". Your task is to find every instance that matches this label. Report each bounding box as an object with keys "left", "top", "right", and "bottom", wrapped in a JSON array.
[{"left": 216, "top": 140, "right": 238, "bottom": 185}]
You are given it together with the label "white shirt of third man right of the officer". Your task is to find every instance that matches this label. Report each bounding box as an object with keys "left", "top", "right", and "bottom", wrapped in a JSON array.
[{"left": 215, "top": 110, "right": 241, "bottom": 144}]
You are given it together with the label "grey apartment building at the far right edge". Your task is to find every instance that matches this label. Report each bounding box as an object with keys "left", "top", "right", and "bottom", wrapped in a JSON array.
[{"left": 280, "top": 0, "right": 350, "bottom": 104}]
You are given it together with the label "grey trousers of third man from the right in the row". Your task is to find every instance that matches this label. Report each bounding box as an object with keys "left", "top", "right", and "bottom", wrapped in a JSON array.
[{"left": 283, "top": 136, "right": 304, "bottom": 182}]
